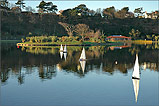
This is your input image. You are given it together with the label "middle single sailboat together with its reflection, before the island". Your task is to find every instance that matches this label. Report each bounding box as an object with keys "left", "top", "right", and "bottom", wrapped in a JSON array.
[{"left": 79, "top": 48, "right": 86, "bottom": 74}]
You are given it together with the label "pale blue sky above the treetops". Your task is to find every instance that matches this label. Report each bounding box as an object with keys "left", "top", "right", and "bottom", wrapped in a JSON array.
[{"left": 9, "top": 0, "right": 159, "bottom": 12}]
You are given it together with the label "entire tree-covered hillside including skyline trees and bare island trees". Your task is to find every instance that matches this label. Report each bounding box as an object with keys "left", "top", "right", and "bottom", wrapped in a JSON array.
[{"left": 1, "top": 0, "right": 159, "bottom": 40}]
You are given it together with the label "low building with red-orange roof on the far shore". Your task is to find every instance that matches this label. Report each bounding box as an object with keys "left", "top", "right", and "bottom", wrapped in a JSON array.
[{"left": 106, "top": 35, "right": 131, "bottom": 41}]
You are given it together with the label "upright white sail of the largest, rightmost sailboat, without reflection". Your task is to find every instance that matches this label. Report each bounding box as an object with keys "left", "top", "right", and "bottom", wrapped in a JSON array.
[{"left": 132, "top": 54, "right": 140, "bottom": 78}]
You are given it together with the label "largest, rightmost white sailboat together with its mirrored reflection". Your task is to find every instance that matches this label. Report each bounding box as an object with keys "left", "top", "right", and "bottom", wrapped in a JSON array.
[{"left": 132, "top": 54, "right": 140, "bottom": 102}]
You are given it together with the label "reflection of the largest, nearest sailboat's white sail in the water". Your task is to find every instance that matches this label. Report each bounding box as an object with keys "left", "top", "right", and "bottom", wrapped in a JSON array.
[{"left": 132, "top": 79, "right": 140, "bottom": 102}]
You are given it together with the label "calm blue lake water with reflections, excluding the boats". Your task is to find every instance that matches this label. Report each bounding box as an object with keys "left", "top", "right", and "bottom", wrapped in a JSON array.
[{"left": 0, "top": 43, "right": 159, "bottom": 106}]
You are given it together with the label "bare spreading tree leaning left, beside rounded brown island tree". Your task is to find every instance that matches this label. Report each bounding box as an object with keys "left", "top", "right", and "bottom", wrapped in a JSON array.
[{"left": 58, "top": 22, "right": 75, "bottom": 36}]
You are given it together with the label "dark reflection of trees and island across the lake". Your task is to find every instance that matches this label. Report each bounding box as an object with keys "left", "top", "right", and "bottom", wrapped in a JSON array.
[{"left": 1, "top": 45, "right": 159, "bottom": 84}]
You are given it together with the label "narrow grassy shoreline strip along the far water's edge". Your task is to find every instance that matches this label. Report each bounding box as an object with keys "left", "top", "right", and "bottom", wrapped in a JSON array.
[{"left": 0, "top": 40, "right": 159, "bottom": 46}]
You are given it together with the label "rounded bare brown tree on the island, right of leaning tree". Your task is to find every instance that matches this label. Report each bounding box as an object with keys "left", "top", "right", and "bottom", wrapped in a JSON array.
[{"left": 75, "top": 24, "right": 90, "bottom": 41}]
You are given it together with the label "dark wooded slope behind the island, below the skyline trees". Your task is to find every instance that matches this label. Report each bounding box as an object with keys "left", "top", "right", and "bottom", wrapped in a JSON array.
[{"left": 1, "top": 12, "right": 159, "bottom": 39}]
